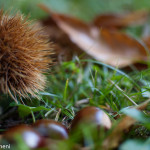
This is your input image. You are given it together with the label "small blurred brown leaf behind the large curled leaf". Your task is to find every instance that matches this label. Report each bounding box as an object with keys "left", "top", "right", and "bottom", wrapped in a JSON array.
[{"left": 93, "top": 10, "right": 148, "bottom": 29}]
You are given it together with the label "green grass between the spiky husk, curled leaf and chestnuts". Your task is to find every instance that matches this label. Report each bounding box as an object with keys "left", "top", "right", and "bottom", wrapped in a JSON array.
[{"left": 1, "top": 57, "right": 150, "bottom": 150}]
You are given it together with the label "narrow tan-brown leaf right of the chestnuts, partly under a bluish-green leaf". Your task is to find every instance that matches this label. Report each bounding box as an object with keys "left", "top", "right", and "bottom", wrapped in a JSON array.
[{"left": 103, "top": 99, "right": 150, "bottom": 150}]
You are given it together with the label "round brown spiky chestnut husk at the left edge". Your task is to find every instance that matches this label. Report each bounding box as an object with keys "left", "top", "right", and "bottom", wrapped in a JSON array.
[{"left": 0, "top": 10, "right": 52, "bottom": 102}]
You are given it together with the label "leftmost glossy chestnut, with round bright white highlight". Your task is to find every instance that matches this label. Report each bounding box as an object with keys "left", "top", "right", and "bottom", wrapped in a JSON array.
[{"left": 4, "top": 125, "right": 46, "bottom": 148}]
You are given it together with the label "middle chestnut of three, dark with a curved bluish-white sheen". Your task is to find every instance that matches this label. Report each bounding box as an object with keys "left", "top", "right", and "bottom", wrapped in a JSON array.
[{"left": 33, "top": 120, "right": 68, "bottom": 140}]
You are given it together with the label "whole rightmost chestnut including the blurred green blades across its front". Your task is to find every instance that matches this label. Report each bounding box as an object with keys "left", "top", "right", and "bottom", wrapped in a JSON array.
[{"left": 70, "top": 107, "right": 111, "bottom": 146}]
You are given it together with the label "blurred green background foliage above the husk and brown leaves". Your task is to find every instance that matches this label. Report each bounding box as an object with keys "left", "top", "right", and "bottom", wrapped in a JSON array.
[{"left": 0, "top": 0, "right": 150, "bottom": 21}]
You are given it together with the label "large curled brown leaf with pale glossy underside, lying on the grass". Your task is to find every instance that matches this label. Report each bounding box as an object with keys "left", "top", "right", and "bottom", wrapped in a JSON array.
[{"left": 38, "top": 5, "right": 147, "bottom": 67}]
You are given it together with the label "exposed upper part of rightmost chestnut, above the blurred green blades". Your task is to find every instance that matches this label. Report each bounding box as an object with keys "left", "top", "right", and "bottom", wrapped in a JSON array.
[{"left": 71, "top": 106, "right": 111, "bottom": 130}]
